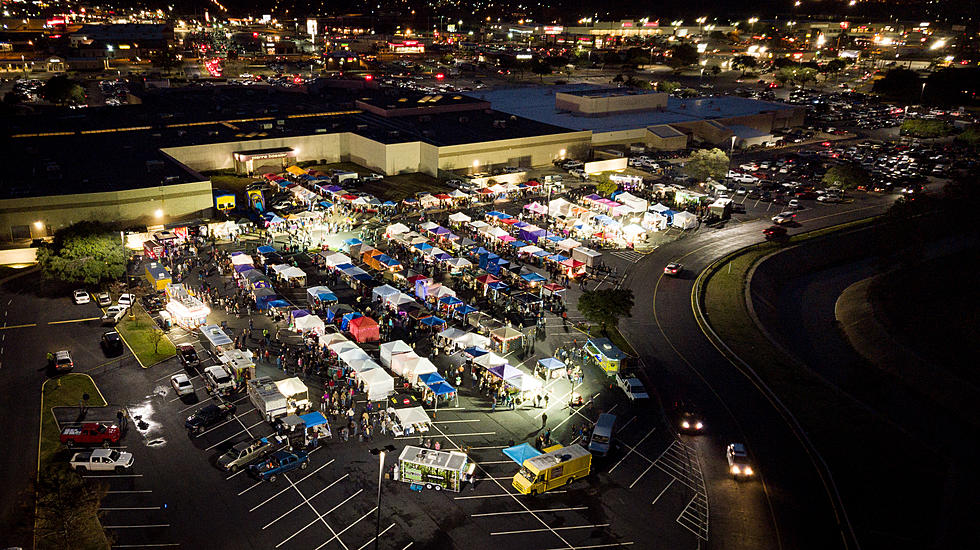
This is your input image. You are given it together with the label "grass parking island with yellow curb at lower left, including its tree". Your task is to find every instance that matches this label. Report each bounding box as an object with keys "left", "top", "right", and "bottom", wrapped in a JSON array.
[{"left": 34, "top": 374, "right": 109, "bottom": 550}]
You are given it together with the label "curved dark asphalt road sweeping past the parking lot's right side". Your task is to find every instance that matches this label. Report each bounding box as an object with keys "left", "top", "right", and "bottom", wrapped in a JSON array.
[{"left": 621, "top": 191, "right": 904, "bottom": 549}]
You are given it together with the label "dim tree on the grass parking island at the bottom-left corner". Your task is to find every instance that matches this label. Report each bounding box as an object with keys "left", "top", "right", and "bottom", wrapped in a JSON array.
[{"left": 35, "top": 464, "right": 107, "bottom": 549}]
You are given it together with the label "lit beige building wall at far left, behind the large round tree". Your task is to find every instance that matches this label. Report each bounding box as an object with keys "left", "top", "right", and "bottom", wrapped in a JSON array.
[{"left": 0, "top": 181, "right": 214, "bottom": 241}]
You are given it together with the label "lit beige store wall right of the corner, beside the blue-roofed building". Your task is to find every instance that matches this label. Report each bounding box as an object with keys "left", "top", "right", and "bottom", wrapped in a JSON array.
[{"left": 439, "top": 131, "right": 592, "bottom": 170}]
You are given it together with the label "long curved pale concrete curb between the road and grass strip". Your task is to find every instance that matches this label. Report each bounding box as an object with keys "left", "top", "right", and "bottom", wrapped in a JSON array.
[{"left": 691, "top": 228, "right": 861, "bottom": 550}]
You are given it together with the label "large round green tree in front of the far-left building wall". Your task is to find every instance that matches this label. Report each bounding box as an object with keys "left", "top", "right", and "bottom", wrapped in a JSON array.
[{"left": 37, "top": 222, "right": 128, "bottom": 285}]
